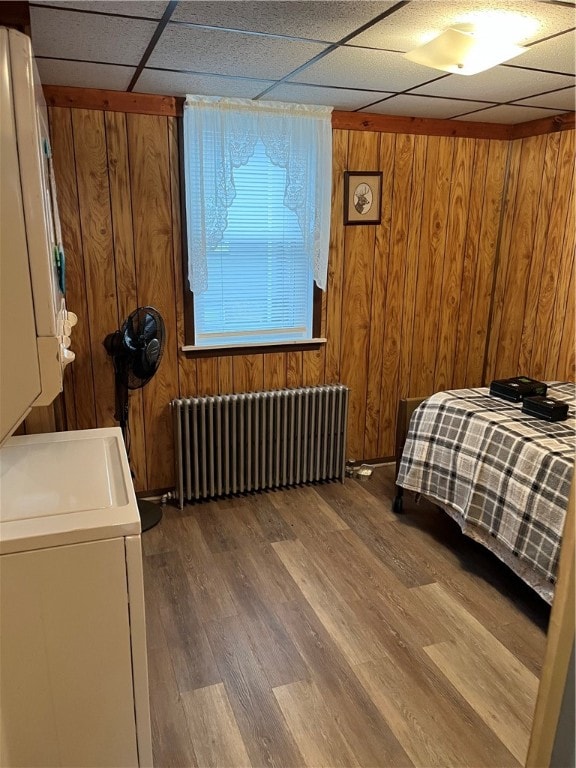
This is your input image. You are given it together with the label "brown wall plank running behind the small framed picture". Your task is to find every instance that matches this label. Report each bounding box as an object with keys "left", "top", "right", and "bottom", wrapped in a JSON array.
[{"left": 340, "top": 131, "right": 379, "bottom": 458}]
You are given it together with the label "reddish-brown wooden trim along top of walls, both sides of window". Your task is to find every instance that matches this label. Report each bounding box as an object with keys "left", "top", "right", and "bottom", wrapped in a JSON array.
[{"left": 43, "top": 85, "right": 575, "bottom": 141}]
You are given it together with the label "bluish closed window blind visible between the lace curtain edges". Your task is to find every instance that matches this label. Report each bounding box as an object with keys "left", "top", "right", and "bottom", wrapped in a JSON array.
[{"left": 191, "top": 141, "right": 313, "bottom": 346}]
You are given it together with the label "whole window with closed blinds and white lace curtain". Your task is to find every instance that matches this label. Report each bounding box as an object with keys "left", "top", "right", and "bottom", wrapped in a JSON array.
[{"left": 184, "top": 96, "right": 332, "bottom": 348}]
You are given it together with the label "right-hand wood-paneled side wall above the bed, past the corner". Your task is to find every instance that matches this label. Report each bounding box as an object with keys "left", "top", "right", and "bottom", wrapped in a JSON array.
[{"left": 487, "top": 131, "right": 576, "bottom": 388}]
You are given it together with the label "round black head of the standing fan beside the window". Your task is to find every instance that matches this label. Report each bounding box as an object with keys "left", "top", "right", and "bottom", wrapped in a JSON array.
[{"left": 120, "top": 307, "right": 166, "bottom": 389}]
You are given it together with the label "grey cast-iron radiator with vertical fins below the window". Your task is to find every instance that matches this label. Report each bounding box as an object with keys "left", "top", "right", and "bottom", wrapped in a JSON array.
[{"left": 170, "top": 384, "right": 348, "bottom": 508}]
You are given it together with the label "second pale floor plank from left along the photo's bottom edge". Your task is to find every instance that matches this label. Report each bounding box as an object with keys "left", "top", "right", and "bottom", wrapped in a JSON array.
[{"left": 274, "top": 680, "right": 360, "bottom": 768}]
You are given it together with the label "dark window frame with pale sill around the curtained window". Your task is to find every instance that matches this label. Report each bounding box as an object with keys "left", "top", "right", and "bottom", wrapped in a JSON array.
[{"left": 176, "top": 117, "right": 327, "bottom": 357}]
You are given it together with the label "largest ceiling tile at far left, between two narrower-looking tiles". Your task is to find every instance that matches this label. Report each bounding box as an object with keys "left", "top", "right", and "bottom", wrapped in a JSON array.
[{"left": 30, "top": 8, "right": 157, "bottom": 65}]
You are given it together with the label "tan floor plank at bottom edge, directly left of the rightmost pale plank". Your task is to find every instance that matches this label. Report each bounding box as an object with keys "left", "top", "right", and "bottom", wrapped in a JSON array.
[{"left": 354, "top": 645, "right": 518, "bottom": 768}]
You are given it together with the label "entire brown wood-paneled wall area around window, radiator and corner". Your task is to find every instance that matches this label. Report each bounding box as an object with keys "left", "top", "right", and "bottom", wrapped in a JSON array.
[{"left": 50, "top": 102, "right": 574, "bottom": 489}]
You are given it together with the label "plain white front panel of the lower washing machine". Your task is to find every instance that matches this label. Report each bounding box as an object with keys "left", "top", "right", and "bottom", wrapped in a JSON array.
[{"left": 0, "top": 538, "right": 138, "bottom": 768}]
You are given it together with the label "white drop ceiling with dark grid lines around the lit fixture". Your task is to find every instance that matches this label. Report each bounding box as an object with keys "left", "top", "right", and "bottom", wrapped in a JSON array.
[{"left": 30, "top": 0, "right": 576, "bottom": 124}]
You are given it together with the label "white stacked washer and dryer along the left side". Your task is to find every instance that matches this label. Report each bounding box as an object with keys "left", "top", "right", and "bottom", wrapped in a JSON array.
[{"left": 0, "top": 28, "right": 152, "bottom": 768}]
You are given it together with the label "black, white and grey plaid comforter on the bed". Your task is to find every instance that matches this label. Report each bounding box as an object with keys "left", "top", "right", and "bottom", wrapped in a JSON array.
[{"left": 397, "top": 383, "right": 576, "bottom": 582}]
